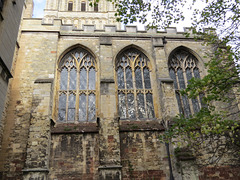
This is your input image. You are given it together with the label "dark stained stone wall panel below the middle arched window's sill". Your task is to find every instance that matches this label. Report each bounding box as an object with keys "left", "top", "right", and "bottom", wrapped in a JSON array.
[{"left": 120, "top": 131, "right": 169, "bottom": 180}]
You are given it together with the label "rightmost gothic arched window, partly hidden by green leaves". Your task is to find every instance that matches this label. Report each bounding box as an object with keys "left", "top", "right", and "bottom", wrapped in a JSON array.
[{"left": 169, "top": 49, "right": 202, "bottom": 117}]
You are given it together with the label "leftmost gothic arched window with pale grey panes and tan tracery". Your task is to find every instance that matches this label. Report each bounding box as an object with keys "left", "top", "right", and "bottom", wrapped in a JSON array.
[{"left": 58, "top": 48, "right": 96, "bottom": 122}]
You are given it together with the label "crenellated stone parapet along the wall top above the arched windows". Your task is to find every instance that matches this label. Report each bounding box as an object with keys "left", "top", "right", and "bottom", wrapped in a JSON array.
[{"left": 22, "top": 18, "right": 204, "bottom": 39}]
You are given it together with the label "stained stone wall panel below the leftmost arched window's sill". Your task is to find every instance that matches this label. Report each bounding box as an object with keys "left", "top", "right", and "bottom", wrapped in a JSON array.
[{"left": 49, "top": 133, "right": 99, "bottom": 180}]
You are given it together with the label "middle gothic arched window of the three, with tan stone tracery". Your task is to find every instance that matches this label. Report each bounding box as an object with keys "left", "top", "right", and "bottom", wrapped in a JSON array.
[{"left": 116, "top": 48, "right": 155, "bottom": 119}]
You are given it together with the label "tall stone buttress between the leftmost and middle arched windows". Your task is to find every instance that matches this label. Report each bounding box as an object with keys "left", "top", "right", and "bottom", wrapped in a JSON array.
[{"left": 99, "top": 37, "right": 121, "bottom": 180}]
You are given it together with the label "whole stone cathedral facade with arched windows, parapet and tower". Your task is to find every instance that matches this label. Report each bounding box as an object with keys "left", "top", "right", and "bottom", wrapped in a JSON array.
[{"left": 0, "top": 0, "right": 240, "bottom": 180}]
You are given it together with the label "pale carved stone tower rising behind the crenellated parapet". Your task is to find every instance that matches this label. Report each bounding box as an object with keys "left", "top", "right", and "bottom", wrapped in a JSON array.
[{"left": 44, "top": 0, "right": 121, "bottom": 29}]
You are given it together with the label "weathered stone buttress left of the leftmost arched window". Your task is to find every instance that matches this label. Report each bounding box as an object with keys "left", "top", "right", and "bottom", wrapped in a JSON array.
[{"left": 23, "top": 79, "right": 52, "bottom": 180}]
